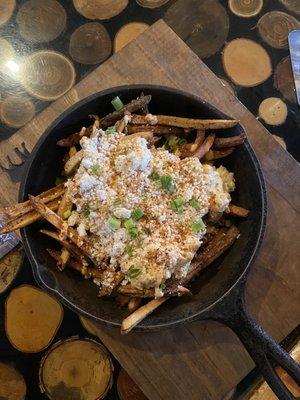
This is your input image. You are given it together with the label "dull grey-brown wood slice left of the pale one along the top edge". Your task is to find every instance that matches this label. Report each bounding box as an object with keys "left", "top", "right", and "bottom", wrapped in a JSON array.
[{"left": 17, "top": 0, "right": 67, "bottom": 43}]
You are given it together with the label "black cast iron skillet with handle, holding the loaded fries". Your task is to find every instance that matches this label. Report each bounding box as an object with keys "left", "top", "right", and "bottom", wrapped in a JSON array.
[{"left": 20, "top": 85, "right": 300, "bottom": 399}]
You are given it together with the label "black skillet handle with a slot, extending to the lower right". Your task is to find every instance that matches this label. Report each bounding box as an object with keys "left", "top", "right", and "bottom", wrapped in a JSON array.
[{"left": 205, "top": 287, "right": 300, "bottom": 400}]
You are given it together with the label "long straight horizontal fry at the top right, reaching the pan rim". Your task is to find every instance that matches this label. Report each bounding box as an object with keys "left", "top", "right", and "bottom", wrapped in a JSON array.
[{"left": 131, "top": 114, "right": 238, "bottom": 129}]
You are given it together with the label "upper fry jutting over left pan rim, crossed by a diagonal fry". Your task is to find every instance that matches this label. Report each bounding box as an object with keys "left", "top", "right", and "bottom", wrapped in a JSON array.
[{"left": 0, "top": 184, "right": 65, "bottom": 218}]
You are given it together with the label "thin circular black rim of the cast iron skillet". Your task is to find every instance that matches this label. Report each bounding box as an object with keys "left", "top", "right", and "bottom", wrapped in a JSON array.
[{"left": 19, "top": 84, "right": 267, "bottom": 332}]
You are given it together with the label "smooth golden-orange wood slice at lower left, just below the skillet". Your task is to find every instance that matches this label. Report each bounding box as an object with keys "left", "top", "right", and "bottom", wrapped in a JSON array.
[{"left": 5, "top": 285, "right": 64, "bottom": 353}]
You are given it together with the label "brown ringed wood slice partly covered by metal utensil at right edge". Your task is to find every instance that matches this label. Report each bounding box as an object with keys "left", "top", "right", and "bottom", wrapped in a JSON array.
[{"left": 257, "top": 11, "right": 300, "bottom": 49}]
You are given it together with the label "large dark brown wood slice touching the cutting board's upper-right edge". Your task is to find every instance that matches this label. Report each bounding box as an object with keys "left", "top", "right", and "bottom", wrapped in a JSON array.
[{"left": 164, "top": 0, "right": 229, "bottom": 58}]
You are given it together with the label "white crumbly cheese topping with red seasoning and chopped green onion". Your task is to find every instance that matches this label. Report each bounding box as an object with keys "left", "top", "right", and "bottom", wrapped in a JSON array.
[{"left": 67, "top": 129, "right": 234, "bottom": 293}]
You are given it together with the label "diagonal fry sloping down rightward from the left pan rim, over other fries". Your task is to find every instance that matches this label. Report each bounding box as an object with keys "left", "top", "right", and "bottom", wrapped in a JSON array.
[{"left": 29, "top": 196, "right": 96, "bottom": 264}]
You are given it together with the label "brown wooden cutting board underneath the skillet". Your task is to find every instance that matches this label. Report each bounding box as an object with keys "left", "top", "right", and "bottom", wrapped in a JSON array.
[{"left": 0, "top": 21, "right": 300, "bottom": 400}]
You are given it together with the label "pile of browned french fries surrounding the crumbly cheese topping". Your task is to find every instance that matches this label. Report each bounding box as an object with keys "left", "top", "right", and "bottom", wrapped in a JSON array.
[{"left": 0, "top": 94, "right": 249, "bottom": 333}]
